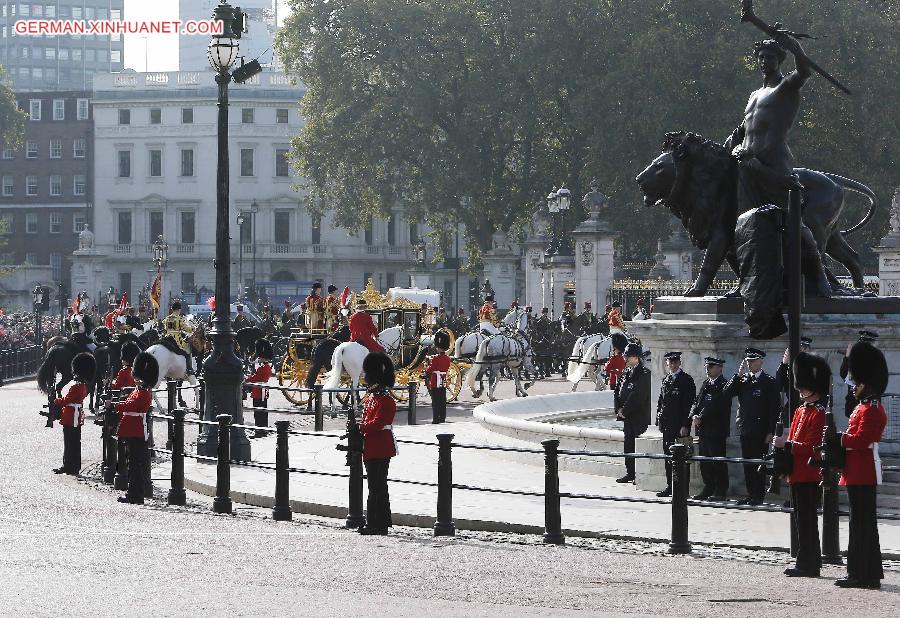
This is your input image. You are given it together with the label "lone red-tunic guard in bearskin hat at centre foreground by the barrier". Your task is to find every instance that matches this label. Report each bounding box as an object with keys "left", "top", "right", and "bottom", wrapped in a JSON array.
[{"left": 359, "top": 352, "right": 397, "bottom": 534}]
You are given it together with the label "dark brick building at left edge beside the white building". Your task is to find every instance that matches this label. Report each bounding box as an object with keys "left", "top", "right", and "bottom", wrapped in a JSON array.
[{"left": 0, "top": 91, "right": 93, "bottom": 285}]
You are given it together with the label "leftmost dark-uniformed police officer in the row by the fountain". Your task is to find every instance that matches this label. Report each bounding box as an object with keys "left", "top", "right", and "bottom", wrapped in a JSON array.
[{"left": 616, "top": 343, "right": 650, "bottom": 483}]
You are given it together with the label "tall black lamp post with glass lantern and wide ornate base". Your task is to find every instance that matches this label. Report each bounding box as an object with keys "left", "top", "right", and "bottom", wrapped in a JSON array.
[{"left": 197, "top": 2, "right": 261, "bottom": 461}]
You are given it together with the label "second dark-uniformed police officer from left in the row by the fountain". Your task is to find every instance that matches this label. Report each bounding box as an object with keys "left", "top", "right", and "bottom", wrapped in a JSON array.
[{"left": 656, "top": 352, "right": 697, "bottom": 498}]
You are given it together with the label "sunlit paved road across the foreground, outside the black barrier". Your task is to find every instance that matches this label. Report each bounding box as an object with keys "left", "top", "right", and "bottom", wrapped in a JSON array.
[{"left": 0, "top": 383, "right": 900, "bottom": 616}]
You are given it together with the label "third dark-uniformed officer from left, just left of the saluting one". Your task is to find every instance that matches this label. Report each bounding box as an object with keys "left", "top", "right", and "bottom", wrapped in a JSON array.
[{"left": 691, "top": 356, "right": 731, "bottom": 501}]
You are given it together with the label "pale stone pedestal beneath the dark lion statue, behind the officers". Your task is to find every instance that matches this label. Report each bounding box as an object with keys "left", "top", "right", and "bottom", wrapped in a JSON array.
[{"left": 628, "top": 297, "right": 900, "bottom": 494}]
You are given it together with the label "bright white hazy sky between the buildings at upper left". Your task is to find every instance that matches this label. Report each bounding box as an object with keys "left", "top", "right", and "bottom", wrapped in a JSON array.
[{"left": 125, "top": 0, "right": 287, "bottom": 71}]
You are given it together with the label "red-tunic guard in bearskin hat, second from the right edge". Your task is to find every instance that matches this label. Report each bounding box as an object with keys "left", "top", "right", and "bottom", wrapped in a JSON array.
[{"left": 772, "top": 352, "right": 831, "bottom": 577}]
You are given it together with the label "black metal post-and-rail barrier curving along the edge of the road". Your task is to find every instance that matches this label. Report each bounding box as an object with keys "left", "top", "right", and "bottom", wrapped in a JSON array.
[{"left": 93, "top": 382, "right": 900, "bottom": 552}]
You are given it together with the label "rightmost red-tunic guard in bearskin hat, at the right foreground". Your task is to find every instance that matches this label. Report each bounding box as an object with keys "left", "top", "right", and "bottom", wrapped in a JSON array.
[{"left": 825, "top": 341, "right": 888, "bottom": 588}]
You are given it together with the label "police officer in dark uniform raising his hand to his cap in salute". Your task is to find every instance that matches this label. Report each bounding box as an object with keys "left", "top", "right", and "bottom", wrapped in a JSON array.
[{"left": 725, "top": 348, "right": 781, "bottom": 505}]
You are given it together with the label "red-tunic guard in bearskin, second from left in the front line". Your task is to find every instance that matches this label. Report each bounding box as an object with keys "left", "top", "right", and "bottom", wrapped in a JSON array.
[{"left": 115, "top": 352, "right": 159, "bottom": 504}]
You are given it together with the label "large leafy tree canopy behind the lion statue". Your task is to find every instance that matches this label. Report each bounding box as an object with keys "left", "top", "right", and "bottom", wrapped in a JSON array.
[{"left": 278, "top": 0, "right": 900, "bottom": 268}]
